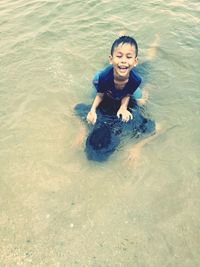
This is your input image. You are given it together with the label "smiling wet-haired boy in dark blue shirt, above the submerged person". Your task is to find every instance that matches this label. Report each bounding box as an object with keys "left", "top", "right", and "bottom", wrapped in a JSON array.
[{"left": 87, "top": 36, "right": 141, "bottom": 124}]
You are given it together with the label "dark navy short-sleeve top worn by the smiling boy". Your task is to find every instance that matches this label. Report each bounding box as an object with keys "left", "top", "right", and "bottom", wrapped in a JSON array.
[{"left": 96, "top": 66, "right": 141, "bottom": 100}]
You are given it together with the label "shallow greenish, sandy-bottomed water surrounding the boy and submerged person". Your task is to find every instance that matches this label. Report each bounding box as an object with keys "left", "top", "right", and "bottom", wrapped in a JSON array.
[{"left": 0, "top": 0, "right": 200, "bottom": 267}]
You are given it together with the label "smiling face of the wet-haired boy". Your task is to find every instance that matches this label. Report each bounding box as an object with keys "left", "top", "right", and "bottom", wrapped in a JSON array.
[{"left": 109, "top": 44, "right": 138, "bottom": 79}]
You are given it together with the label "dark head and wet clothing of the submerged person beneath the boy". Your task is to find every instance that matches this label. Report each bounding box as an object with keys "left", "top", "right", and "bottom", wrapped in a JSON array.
[{"left": 75, "top": 96, "right": 155, "bottom": 161}]
